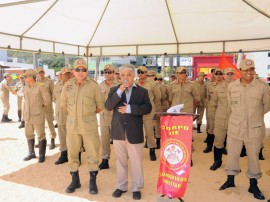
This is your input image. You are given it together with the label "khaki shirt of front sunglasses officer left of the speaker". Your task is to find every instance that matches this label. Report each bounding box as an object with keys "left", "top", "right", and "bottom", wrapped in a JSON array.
[{"left": 60, "top": 78, "right": 104, "bottom": 134}]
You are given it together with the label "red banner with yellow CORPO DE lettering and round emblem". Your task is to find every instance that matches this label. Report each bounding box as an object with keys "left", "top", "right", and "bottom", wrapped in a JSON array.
[{"left": 157, "top": 115, "right": 193, "bottom": 198}]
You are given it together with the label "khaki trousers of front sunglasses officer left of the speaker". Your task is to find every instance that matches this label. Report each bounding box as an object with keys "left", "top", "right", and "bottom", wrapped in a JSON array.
[{"left": 66, "top": 132, "right": 100, "bottom": 172}]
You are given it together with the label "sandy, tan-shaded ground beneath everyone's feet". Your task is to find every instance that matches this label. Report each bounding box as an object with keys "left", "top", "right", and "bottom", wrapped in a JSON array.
[{"left": 0, "top": 95, "right": 270, "bottom": 202}]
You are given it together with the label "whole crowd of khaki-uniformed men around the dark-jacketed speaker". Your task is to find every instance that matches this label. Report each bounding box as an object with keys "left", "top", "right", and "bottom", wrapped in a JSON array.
[{"left": 0, "top": 59, "right": 270, "bottom": 200}]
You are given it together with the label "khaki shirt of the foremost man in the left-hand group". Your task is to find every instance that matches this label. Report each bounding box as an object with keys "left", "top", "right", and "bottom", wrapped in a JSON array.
[{"left": 23, "top": 82, "right": 51, "bottom": 124}]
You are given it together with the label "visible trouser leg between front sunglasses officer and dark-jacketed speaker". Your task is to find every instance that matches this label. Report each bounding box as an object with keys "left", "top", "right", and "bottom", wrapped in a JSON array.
[{"left": 100, "top": 125, "right": 111, "bottom": 159}]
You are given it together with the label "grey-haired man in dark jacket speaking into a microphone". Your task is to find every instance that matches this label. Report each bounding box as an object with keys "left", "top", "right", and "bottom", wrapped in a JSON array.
[{"left": 105, "top": 64, "right": 152, "bottom": 200}]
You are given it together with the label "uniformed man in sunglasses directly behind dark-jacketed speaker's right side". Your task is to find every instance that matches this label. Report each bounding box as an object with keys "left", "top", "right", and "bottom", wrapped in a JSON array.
[{"left": 136, "top": 66, "right": 161, "bottom": 161}]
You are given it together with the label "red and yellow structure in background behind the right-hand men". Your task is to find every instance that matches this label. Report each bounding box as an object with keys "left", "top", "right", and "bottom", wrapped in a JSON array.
[{"left": 192, "top": 55, "right": 235, "bottom": 79}]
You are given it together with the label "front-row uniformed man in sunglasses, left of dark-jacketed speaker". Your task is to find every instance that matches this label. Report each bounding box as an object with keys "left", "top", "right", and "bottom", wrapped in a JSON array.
[{"left": 60, "top": 59, "right": 104, "bottom": 194}]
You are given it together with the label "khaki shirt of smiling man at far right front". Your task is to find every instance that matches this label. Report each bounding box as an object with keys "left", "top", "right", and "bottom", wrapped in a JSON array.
[{"left": 227, "top": 79, "right": 269, "bottom": 141}]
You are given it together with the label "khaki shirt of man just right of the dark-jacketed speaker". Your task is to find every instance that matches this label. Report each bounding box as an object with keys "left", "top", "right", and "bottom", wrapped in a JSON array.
[{"left": 136, "top": 78, "right": 161, "bottom": 117}]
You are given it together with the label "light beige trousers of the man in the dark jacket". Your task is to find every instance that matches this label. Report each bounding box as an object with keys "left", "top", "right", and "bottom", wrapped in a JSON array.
[{"left": 113, "top": 140, "right": 144, "bottom": 192}]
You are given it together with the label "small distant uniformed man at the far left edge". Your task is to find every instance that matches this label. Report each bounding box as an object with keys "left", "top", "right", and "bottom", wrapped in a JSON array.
[{"left": 0, "top": 73, "right": 16, "bottom": 122}]
